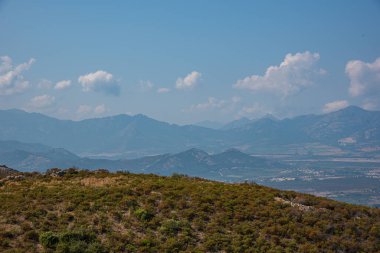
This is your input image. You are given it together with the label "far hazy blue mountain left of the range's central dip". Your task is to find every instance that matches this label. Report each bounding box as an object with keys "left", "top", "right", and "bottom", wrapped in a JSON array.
[{"left": 0, "top": 110, "right": 224, "bottom": 157}]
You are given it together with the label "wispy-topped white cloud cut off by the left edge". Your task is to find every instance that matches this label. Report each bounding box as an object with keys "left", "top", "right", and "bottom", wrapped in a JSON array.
[{"left": 0, "top": 56, "right": 35, "bottom": 95}]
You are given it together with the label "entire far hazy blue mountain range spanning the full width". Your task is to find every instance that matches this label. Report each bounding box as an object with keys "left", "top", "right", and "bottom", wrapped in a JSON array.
[{"left": 0, "top": 107, "right": 380, "bottom": 158}]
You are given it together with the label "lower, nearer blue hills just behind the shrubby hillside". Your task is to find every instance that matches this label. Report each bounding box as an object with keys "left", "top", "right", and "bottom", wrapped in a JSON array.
[{"left": 0, "top": 141, "right": 280, "bottom": 177}]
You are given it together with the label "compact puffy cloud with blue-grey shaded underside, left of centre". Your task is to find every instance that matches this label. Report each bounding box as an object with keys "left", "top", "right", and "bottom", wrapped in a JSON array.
[{"left": 78, "top": 70, "right": 120, "bottom": 96}]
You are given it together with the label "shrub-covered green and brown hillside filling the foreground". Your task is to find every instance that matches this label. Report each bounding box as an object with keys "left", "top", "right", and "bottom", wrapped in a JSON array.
[{"left": 0, "top": 169, "right": 380, "bottom": 252}]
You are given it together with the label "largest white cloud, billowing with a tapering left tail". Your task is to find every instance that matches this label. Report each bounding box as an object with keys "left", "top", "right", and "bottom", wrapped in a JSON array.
[{"left": 233, "top": 51, "right": 325, "bottom": 97}]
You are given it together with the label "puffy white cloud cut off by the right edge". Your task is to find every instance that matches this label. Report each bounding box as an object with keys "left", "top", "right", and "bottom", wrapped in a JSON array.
[{"left": 346, "top": 58, "right": 380, "bottom": 97}]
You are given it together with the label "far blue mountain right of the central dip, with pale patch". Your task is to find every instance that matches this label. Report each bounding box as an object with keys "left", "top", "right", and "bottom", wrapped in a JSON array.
[{"left": 231, "top": 106, "right": 380, "bottom": 153}]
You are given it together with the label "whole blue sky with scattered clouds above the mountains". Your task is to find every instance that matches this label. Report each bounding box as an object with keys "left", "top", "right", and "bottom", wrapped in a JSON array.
[{"left": 0, "top": 0, "right": 380, "bottom": 124}]
